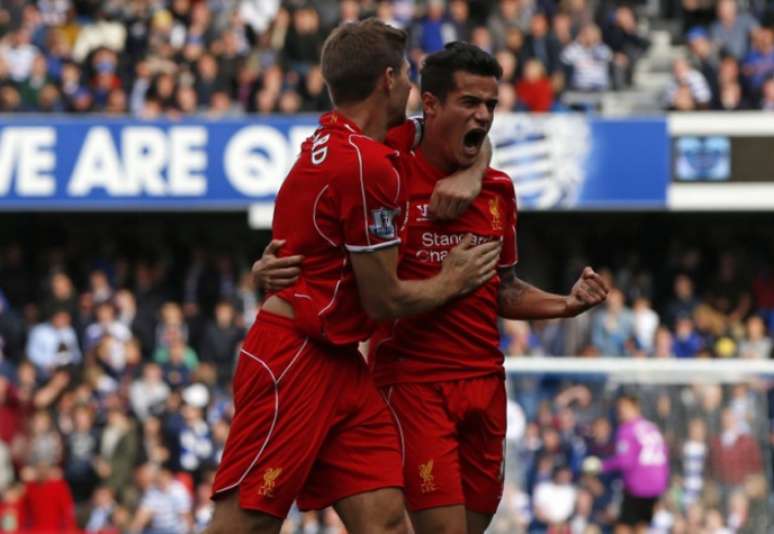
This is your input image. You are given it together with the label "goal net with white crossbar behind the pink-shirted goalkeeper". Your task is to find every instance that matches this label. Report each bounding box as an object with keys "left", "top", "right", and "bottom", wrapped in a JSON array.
[{"left": 489, "top": 358, "right": 774, "bottom": 534}]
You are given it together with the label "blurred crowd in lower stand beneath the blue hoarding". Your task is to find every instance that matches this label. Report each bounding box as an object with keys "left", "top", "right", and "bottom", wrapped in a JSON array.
[{"left": 0, "top": 220, "right": 774, "bottom": 533}]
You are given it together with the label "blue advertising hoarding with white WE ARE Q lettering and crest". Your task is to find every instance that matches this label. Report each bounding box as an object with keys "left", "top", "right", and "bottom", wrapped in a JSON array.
[{"left": 0, "top": 114, "right": 669, "bottom": 210}]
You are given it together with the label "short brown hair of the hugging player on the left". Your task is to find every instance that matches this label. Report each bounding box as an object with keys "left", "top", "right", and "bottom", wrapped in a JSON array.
[{"left": 321, "top": 18, "right": 408, "bottom": 105}]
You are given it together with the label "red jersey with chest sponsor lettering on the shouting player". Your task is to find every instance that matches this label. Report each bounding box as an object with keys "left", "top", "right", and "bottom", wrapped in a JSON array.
[{"left": 370, "top": 150, "right": 518, "bottom": 385}]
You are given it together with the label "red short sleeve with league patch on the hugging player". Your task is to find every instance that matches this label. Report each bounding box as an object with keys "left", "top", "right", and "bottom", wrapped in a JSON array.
[{"left": 336, "top": 136, "right": 401, "bottom": 252}]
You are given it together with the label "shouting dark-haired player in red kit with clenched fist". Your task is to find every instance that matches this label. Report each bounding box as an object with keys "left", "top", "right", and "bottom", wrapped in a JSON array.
[{"left": 258, "top": 43, "right": 607, "bottom": 534}]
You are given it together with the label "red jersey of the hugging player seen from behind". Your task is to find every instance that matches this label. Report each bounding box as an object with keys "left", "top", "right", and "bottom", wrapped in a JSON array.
[{"left": 272, "top": 112, "right": 414, "bottom": 345}]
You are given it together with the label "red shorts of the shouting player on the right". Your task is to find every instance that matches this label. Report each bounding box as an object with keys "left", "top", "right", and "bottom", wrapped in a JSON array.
[{"left": 384, "top": 375, "right": 507, "bottom": 514}]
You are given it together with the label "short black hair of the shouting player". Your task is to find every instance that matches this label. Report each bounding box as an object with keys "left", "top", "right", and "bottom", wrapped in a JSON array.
[{"left": 421, "top": 41, "right": 503, "bottom": 101}]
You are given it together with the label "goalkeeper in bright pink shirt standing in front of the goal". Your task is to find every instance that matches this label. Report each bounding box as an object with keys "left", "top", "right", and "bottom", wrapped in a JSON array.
[{"left": 584, "top": 395, "right": 669, "bottom": 534}]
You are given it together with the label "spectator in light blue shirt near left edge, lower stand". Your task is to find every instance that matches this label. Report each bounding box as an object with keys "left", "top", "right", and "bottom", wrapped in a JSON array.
[{"left": 27, "top": 308, "right": 81, "bottom": 376}]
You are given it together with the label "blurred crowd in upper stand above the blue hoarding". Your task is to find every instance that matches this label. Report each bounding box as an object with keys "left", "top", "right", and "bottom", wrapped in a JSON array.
[{"left": 0, "top": 0, "right": 774, "bottom": 115}]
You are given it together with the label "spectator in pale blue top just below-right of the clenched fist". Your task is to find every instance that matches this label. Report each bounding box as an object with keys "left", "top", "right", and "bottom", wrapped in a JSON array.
[{"left": 591, "top": 288, "right": 634, "bottom": 356}]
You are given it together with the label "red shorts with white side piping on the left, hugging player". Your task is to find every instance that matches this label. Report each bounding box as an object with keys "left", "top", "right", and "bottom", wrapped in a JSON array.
[{"left": 213, "top": 312, "right": 403, "bottom": 518}]
